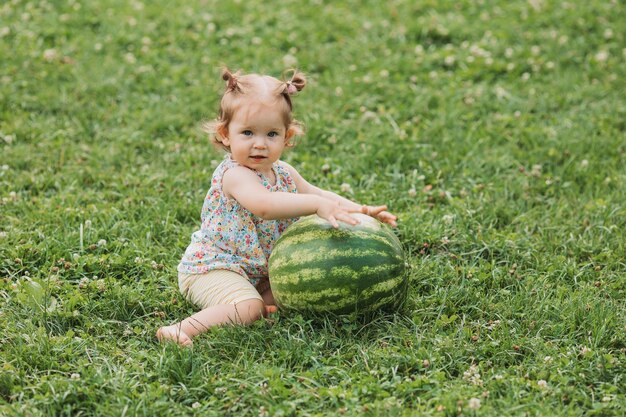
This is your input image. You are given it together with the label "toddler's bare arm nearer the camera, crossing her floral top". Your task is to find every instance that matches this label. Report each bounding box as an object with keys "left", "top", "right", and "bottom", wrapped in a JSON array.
[{"left": 222, "top": 167, "right": 360, "bottom": 227}]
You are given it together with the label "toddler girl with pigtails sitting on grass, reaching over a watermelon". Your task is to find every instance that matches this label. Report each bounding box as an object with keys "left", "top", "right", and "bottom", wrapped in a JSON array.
[{"left": 157, "top": 70, "right": 396, "bottom": 346}]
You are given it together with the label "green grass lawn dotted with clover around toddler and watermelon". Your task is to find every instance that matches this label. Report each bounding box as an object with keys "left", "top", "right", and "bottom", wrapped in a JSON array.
[{"left": 0, "top": 0, "right": 626, "bottom": 416}]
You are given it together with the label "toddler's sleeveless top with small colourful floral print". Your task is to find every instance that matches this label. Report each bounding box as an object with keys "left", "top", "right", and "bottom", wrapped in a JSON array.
[{"left": 178, "top": 155, "right": 297, "bottom": 285}]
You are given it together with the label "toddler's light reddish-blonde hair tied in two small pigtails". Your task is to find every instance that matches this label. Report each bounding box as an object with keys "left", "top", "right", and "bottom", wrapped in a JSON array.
[{"left": 202, "top": 68, "right": 306, "bottom": 152}]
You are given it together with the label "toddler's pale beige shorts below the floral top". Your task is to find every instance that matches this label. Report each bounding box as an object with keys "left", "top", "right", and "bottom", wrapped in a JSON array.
[{"left": 178, "top": 269, "right": 269, "bottom": 309}]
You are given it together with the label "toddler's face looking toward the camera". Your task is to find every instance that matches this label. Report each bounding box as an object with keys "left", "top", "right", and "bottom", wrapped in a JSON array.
[{"left": 222, "top": 104, "right": 291, "bottom": 176}]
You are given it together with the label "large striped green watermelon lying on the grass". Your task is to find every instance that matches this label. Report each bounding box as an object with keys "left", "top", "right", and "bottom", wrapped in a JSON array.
[{"left": 269, "top": 213, "right": 408, "bottom": 315}]
